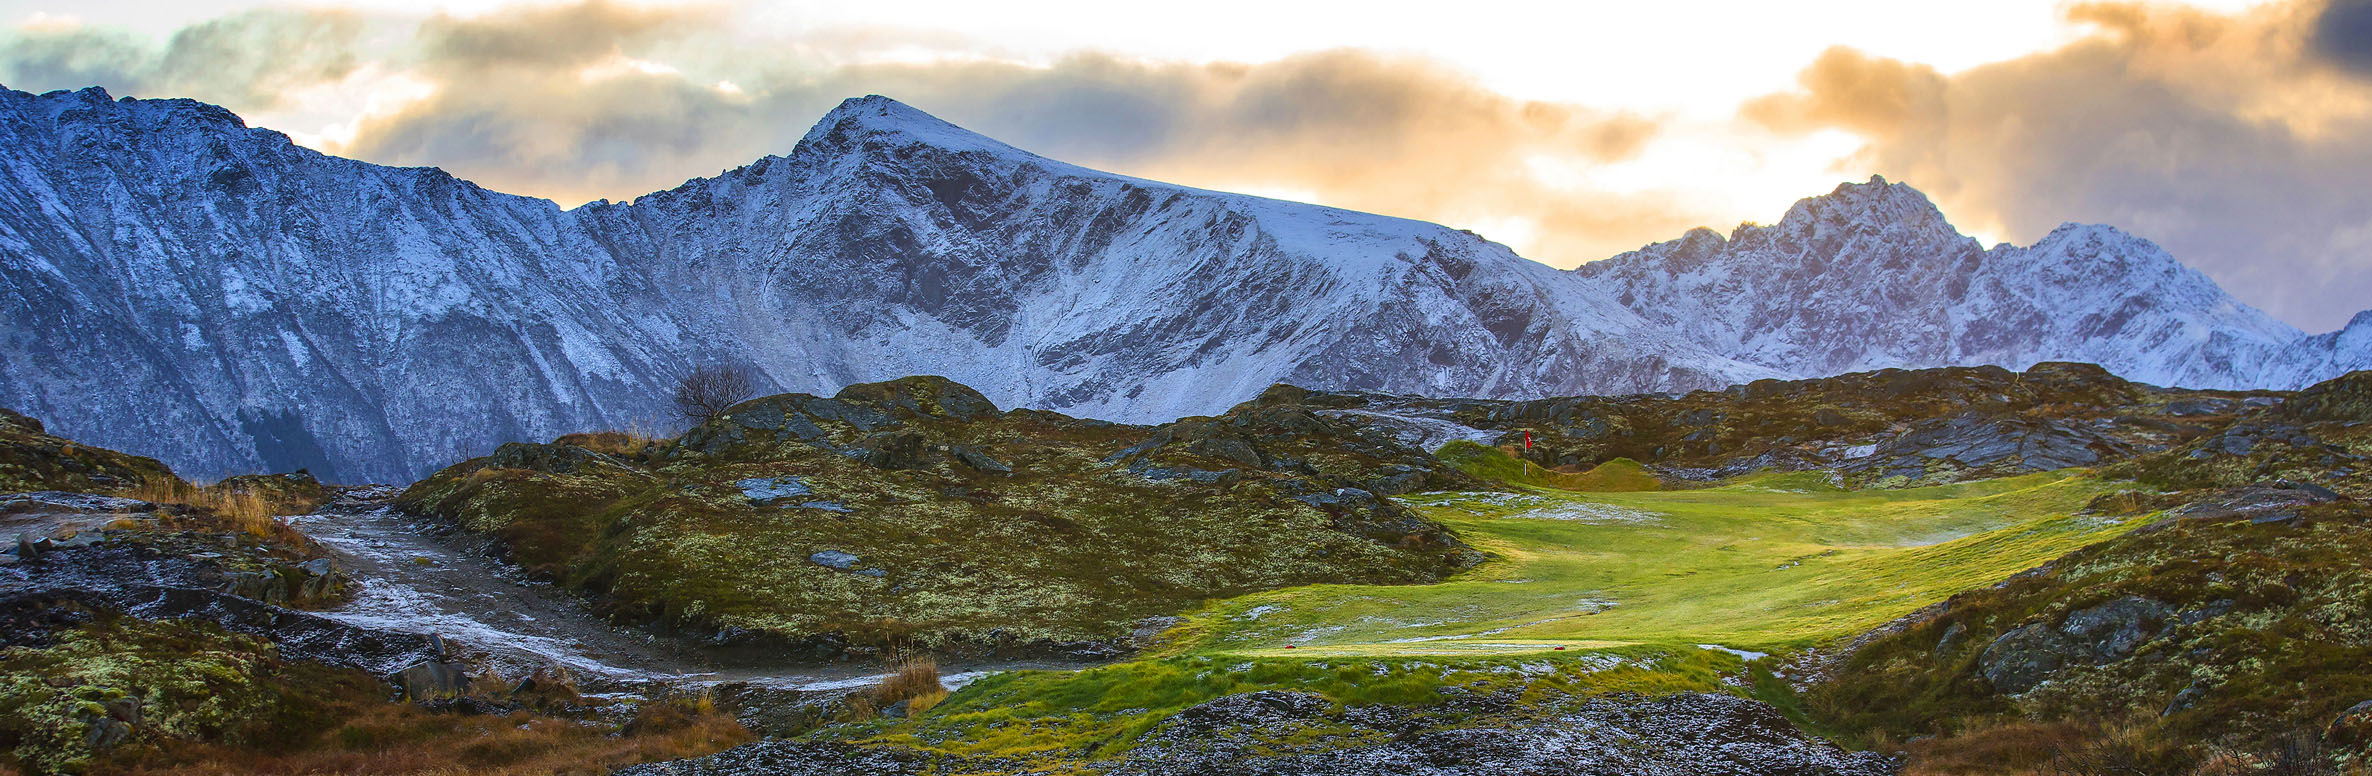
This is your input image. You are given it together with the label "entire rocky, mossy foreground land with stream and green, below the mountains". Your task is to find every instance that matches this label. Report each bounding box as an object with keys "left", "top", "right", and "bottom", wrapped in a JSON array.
[{"left": 0, "top": 363, "right": 2372, "bottom": 776}]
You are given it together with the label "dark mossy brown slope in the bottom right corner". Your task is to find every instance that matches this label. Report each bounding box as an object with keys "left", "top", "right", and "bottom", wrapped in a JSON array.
[{"left": 1805, "top": 503, "right": 2372, "bottom": 771}]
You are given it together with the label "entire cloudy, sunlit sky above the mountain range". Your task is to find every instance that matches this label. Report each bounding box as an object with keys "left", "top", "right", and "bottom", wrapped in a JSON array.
[{"left": 0, "top": 0, "right": 2372, "bottom": 332}]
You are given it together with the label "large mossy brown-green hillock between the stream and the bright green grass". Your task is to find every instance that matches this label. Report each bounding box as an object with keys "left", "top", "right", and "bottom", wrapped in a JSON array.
[{"left": 398, "top": 377, "right": 1480, "bottom": 657}]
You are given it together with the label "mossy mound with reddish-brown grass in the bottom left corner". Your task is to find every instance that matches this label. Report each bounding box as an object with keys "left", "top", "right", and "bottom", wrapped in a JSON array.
[{"left": 0, "top": 612, "right": 750, "bottom": 776}]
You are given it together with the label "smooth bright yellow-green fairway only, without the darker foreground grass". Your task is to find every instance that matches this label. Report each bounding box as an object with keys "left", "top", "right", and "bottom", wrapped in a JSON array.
[{"left": 1174, "top": 475, "right": 2142, "bottom": 655}]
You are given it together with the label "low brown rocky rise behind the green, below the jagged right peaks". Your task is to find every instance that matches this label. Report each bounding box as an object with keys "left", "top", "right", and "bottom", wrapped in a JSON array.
[{"left": 1307, "top": 363, "right": 2287, "bottom": 486}]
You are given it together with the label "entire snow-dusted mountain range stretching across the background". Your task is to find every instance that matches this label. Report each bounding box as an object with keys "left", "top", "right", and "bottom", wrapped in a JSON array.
[{"left": 0, "top": 88, "right": 2372, "bottom": 482}]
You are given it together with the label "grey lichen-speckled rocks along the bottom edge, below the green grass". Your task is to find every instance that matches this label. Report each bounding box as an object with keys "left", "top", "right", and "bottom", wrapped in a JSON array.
[{"left": 619, "top": 691, "right": 1895, "bottom": 776}]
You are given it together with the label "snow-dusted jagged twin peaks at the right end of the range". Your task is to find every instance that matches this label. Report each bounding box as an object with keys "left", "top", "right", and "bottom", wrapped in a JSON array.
[{"left": 1575, "top": 178, "right": 2367, "bottom": 387}]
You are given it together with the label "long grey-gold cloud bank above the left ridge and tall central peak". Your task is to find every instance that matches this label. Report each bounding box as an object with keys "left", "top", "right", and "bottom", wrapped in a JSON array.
[{"left": 0, "top": 0, "right": 1708, "bottom": 266}]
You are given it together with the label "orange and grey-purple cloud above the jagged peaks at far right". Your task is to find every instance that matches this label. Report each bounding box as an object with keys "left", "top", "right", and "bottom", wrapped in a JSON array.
[{"left": 1741, "top": 2, "right": 2372, "bottom": 330}]
